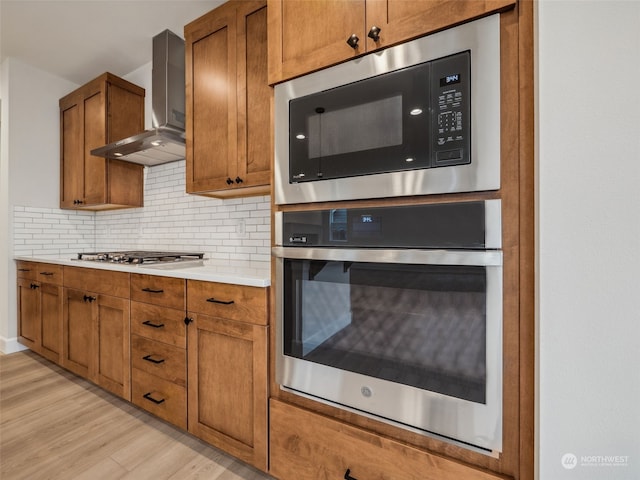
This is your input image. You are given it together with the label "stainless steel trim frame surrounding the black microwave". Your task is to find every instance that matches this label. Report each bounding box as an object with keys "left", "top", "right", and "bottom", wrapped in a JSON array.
[{"left": 274, "top": 14, "right": 500, "bottom": 204}]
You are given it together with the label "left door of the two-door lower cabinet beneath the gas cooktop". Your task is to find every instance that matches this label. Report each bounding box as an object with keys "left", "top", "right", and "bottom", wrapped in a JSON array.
[{"left": 62, "top": 289, "right": 97, "bottom": 378}]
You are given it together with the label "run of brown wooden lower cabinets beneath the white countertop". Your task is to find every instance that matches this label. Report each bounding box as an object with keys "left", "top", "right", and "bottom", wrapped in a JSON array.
[{"left": 17, "top": 262, "right": 269, "bottom": 472}]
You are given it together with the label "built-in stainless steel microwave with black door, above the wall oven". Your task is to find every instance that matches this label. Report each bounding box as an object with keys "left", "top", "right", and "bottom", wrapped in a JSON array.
[{"left": 274, "top": 15, "right": 500, "bottom": 204}]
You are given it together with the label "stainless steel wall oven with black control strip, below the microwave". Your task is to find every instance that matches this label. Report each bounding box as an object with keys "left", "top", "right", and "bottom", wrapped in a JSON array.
[{"left": 273, "top": 200, "right": 502, "bottom": 453}]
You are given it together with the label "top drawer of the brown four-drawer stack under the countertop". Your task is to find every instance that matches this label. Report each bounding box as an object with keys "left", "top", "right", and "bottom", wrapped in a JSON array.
[{"left": 131, "top": 274, "right": 185, "bottom": 310}]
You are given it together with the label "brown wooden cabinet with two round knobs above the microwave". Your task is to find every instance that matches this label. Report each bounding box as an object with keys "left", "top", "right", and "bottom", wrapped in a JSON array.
[{"left": 267, "top": 0, "right": 516, "bottom": 84}]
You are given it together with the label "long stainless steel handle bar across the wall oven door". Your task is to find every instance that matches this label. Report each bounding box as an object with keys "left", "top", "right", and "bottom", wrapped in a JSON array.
[{"left": 271, "top": 247, "right": 502, "bottom": 267}]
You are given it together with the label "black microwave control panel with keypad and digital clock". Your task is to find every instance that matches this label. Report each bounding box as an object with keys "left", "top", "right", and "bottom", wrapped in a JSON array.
[{"left": 430, "top": 51, "right": 471, "bottom": 167}]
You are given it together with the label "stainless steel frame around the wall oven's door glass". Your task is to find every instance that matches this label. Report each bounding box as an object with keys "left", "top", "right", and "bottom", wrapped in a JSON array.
[{"left": 273, "top": 253, "right": 503, "bottom": 456}]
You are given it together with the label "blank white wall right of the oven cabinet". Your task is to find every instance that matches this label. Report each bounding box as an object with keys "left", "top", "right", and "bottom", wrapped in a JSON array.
[{"left": 537, "top": 0, "right": 640, "bottom": 480}]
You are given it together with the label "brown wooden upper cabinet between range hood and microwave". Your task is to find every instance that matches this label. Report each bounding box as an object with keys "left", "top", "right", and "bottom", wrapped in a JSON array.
[{"left": 185, "top": 0, "right": 271, "bottom": 197}]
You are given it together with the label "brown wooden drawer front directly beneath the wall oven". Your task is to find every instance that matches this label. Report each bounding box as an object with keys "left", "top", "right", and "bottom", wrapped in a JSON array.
[{"left": 269, "top": 400, "right": 504, "bottom": 480}]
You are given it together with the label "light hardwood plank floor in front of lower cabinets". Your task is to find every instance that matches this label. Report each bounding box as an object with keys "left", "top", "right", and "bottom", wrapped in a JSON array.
[{"left": 0, "top": 351, "right": 271, "bottom": 480}]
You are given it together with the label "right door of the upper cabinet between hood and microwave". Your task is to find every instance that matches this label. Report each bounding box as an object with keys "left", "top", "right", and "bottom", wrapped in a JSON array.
[{"left": 237, "top": 1, "right": 271, "bottom": 187}]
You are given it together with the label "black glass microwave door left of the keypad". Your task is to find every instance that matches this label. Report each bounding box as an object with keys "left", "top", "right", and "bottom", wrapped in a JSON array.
[{"left": 289, "top": 58, "right": 430, "bottom": 183}]
